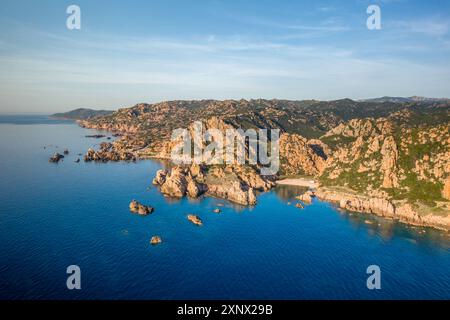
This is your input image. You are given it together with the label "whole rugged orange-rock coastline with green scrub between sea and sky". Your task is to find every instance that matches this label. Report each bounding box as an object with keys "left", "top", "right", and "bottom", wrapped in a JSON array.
[{"left": 71, "top": 99, "right": 450, "bottom": 231}]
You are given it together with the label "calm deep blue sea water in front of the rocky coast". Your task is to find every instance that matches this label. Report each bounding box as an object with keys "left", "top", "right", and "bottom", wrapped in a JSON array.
[{"left": 0, "top": 116, "right": 450, "bottom": 299}]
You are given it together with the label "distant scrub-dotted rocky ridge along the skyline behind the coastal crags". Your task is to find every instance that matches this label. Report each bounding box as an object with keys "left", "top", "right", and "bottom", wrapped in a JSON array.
[{"left": 78, "top": 99, "right": 450, "bottom": 138}]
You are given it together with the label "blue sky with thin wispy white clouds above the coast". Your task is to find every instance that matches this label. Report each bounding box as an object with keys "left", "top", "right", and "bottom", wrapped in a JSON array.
[{"left": 0, "top": 0, "right": 450, "bottom": 113}]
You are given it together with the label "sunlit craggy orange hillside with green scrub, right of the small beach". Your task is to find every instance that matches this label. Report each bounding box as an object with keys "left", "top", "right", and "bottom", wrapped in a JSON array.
[{"left": 320, "top": 114, "right": 450, "bottom": 207}]
